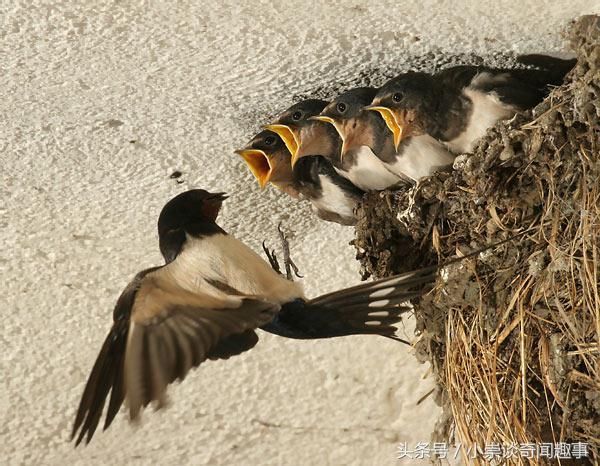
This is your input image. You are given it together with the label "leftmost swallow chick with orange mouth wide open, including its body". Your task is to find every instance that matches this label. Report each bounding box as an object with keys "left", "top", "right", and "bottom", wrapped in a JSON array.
[{"left": 236, "top": 130, "right": 364, "bottom": 225}]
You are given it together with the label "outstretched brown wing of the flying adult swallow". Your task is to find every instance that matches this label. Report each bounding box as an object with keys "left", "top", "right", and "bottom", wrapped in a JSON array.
[{"left": 72, "top": 268, "right": 279, "bottom": 444}]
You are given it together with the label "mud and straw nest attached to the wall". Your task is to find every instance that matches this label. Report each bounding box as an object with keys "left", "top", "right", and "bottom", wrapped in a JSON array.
[{"left": 354, "top": 16, "right": 600, "bottom": 464}]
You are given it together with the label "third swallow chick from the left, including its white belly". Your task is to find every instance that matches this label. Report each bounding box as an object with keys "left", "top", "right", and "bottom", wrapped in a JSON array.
[{"left": 314, "top": 87, "right": 454, "bottom": 183}]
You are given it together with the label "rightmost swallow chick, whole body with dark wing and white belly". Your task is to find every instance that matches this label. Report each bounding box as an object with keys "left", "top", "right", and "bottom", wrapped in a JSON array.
[{"left": 370, "top": 55, "right": 574, "bottom": 153}]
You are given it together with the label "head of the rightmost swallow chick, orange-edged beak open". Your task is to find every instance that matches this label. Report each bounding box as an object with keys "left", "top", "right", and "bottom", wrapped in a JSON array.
[{"left": 367, "top": 73, "right": 436, "bottom": 150}]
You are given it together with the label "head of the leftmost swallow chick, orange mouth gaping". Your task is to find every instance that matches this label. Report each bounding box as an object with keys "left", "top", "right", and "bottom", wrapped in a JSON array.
[{"left": 235, "top": 130, "right": 293, "bottom": 189}]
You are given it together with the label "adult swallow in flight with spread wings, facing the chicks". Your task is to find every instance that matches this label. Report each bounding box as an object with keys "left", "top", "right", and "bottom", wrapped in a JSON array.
[{"left": 72, "top": 189, "right": 437, "bottom": 444}]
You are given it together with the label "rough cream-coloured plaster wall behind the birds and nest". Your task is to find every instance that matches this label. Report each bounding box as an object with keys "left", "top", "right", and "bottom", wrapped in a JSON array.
[{"left": 0, "top": 0, "right": 600, "bottom": 465}]
